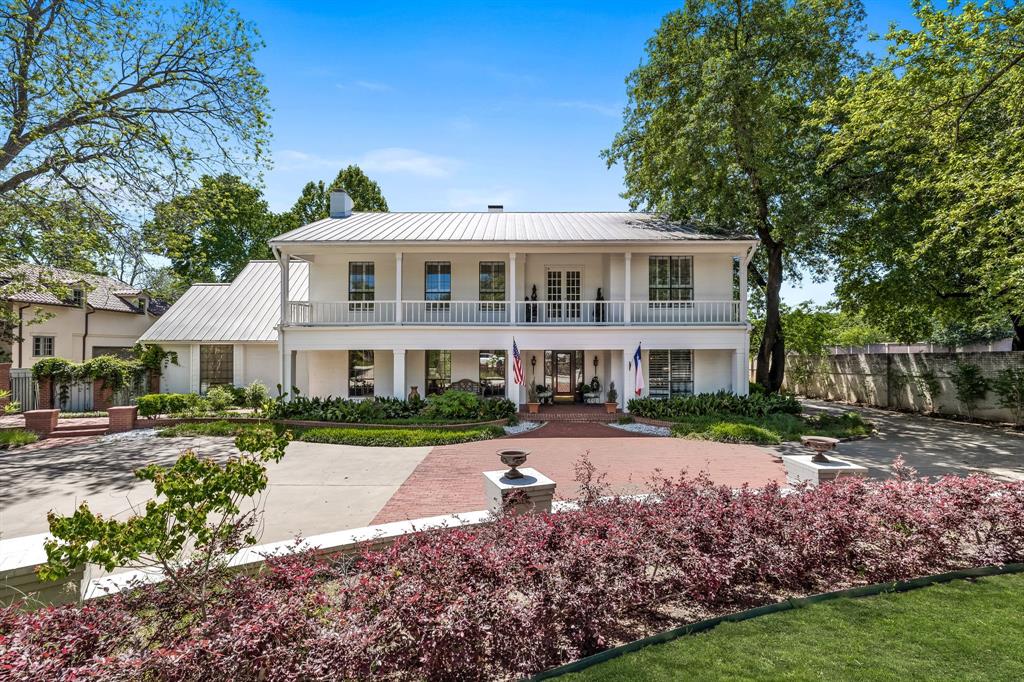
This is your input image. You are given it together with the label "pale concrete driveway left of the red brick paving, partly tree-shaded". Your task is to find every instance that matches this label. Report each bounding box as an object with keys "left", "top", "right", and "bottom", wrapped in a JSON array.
[{"left": 0, "top": 437, "right": 430, "bottom": 542}]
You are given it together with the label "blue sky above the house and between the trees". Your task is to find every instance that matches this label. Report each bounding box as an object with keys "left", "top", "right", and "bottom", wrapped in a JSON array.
[{"left": 247, "top": 0, "right": 911, "bottom": 303}]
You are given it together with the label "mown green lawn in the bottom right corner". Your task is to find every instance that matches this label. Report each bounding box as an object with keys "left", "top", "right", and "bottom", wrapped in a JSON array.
[{"left": 560, "top": 574, "right": 1024, "bottom": 682}]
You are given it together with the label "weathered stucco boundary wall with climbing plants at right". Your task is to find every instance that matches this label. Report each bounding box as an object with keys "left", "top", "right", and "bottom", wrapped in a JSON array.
[{"left": 786, "top": 352, "right": 1024, "bottom": 421}]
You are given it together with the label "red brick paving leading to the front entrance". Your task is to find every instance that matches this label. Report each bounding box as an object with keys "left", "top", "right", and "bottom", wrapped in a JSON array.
[{"left": 373, "top": 424, "right": 785, "bottom": 523}]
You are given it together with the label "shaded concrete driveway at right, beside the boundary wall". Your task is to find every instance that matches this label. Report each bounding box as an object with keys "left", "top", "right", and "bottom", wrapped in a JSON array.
[{"left": 778, "top": 400, "right": 1024, "bottom": 480}]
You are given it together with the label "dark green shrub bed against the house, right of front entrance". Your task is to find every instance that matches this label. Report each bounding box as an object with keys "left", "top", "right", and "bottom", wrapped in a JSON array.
[{"left": 629, "top": 391, "right": 802, "bottom": 420}]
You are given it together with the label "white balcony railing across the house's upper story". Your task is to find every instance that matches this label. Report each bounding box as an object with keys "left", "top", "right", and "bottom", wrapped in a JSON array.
[{"left": 289, "top": 301, "right": 743, "bottom": 327}]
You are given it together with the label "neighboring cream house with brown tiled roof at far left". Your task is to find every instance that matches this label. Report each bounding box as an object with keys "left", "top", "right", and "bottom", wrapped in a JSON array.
[{"left": 0, "top": 264, "right": 167, "bottom": 368}]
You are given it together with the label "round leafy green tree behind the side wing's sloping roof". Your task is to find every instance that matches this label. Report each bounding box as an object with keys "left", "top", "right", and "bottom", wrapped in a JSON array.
[{"left": 143, "top": 173, "right": 284, "bottom": 285}]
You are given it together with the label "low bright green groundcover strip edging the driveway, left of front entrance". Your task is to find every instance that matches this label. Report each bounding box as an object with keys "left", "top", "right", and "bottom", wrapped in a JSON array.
[{"left": 158, "top": 421, "right": 505, "bottom": 447}]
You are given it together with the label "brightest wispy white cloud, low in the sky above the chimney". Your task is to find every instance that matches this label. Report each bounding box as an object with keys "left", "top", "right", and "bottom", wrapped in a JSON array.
[{"left": 273, "top": 146, "right": 462, "bottom": 177}]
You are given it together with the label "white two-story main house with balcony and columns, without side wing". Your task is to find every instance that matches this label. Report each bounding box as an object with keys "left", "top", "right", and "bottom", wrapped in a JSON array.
[{"left": 270, "top": 188, "right": 757, "bottom": 407}]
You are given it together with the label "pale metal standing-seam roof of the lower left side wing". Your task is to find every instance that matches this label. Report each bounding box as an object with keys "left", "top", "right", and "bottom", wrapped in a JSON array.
[{"left": 139, "top": 260, "right": 309, "bottom": 343}]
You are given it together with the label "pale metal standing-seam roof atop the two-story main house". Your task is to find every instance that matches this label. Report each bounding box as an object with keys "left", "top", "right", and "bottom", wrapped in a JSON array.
[{"left": 270, "top": 212, "right": 756, "bottom": 246}]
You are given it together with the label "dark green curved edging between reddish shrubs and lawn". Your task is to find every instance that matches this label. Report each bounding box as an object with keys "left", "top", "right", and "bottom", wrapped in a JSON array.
[{"left": 527, "top": 563, "right": 1024, "bottom": 682}]
